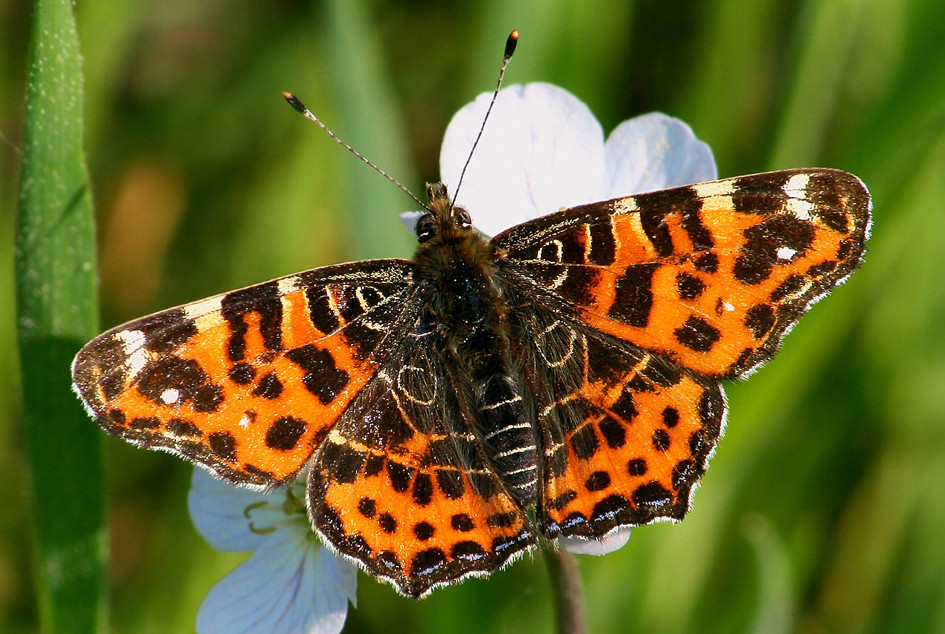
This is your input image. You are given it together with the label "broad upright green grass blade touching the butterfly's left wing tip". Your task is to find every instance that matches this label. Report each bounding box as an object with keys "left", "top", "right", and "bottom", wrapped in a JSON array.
[{"left": 16, "top": 0, "right": 105, "bottom": 632}]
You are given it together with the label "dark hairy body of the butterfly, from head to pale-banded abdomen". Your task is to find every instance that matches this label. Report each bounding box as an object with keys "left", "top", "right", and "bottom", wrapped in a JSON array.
[{"left": 414, "top": 185, "right": 537, "bottom": 505}]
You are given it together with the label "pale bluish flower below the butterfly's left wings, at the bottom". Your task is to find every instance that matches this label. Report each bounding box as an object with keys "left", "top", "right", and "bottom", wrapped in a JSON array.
[{"left": 188, "top": 469, "right": 357, "bottom": 634}]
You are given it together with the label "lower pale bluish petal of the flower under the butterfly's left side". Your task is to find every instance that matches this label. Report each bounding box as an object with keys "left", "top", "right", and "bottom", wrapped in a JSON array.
[{"left": 197, "top": 529, "right": 357, "bottom": 634}]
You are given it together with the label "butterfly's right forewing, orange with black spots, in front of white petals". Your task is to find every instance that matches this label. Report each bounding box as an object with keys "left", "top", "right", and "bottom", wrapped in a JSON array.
[{"left": 495, "top": 170, "right": 870, "bottom": 378}]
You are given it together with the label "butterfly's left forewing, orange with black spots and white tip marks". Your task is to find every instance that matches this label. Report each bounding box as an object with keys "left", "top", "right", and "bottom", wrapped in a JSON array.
[{"left": 73, "top": 260, "right": 411, "bottom": 487}]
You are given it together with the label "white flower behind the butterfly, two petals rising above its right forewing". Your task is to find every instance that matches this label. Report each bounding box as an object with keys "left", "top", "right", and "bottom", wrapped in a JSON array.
[{"left": 440, "top": 83, "right": 718, "bottom": 555}]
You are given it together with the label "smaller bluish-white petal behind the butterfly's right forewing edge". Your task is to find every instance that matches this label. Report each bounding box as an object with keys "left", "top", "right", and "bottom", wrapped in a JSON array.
[{"left": 605, "top": 112, "right": 718, "bottom": 198}]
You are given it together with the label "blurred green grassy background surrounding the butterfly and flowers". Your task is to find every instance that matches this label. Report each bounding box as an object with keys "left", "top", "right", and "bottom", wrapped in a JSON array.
[{"left": 0, "top": 0, "right": 945, "bottom": 633}]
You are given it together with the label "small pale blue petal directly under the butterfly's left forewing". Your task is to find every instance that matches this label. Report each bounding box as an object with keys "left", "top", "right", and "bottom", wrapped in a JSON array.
[{"left": 187, "top": 468, "right": 285, "bottom": 552}]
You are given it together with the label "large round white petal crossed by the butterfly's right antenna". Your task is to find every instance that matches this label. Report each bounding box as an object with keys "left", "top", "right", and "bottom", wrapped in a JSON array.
[{"left": 440, "top": 83, "right": 606, "bottom": 235}]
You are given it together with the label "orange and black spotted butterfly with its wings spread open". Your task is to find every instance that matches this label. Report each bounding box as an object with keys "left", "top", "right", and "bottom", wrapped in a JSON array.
[{"left": 73, "top": 158, "right": 870, "bottom": 597}]
